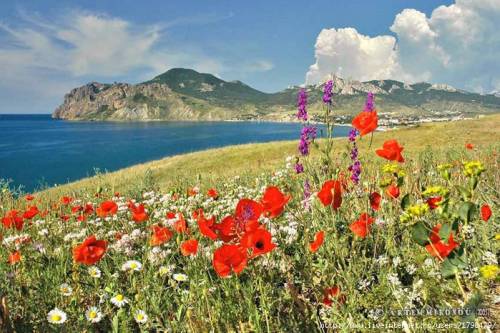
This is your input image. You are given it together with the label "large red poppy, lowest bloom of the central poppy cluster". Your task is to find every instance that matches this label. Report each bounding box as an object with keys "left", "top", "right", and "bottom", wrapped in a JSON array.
[{"left": 212, "top": 244, "right": 247, "bottom": 277}]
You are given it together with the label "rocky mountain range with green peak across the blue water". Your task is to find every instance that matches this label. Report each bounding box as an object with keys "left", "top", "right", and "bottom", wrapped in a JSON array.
[{"left": 52, "top": 68, "right": 500, "bottom": 121}]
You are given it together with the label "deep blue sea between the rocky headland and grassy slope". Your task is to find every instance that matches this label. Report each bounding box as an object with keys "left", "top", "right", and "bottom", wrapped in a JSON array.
[{"left": 0, "top": 114, "right": 349, "bottom": 191}]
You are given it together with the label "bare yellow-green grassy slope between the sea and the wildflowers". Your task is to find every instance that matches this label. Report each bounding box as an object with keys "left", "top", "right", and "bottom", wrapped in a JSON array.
[{"left": 40, "top": 114, "right": 500, "bottom": 198}]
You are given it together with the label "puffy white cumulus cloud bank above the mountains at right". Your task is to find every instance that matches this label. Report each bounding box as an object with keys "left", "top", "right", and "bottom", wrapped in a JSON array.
[{"left": 306, "top": 0, "right": 500, "bottom": 92}]
